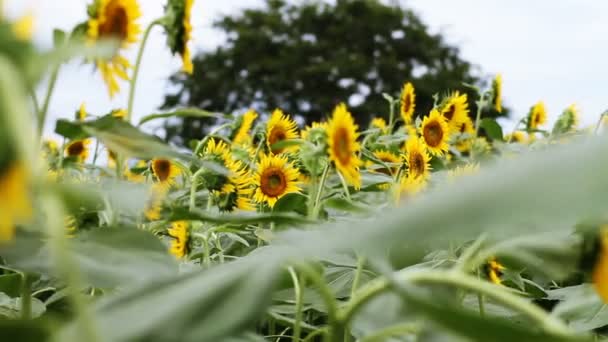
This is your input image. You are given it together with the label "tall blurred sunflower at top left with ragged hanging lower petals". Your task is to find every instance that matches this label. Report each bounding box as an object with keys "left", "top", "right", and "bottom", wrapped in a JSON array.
[{"left": 87, "top": 0, "right": 141, "bottom": 97}]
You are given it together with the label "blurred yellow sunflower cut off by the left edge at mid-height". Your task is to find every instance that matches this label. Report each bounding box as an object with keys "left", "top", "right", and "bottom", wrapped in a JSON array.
[{"left": 0, "top": 163, "right": 32, "bottom": 243}]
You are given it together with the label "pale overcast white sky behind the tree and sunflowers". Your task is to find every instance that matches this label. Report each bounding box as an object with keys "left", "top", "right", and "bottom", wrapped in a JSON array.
[{"left": 4, "top": 0, "right": 608, "bottom": 136}]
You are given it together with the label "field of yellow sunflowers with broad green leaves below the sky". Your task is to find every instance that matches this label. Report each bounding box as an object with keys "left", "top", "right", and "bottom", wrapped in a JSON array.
[{"left": 0, "top": 0, "right": 608, "bottom": 342}]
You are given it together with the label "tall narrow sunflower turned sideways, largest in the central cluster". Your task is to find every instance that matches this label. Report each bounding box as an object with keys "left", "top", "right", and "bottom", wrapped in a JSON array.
[{"left": 327, "top": 103, "right": 362, "bottom": 189}]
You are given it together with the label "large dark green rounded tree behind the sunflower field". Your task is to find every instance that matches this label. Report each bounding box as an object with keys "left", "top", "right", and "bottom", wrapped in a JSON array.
[{"left": 164, "top": 0, "right": 494, "bottom": 142}]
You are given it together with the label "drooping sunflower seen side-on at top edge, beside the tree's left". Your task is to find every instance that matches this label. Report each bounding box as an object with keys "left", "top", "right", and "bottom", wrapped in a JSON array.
[{"left": 162, "top": 0, "right": 194, "bottom": 75}]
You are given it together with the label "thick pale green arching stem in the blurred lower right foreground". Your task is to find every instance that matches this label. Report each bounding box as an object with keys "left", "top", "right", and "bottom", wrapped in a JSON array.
[{"left": 340, "top": 270, "right": 572, "bottom": 336}]
